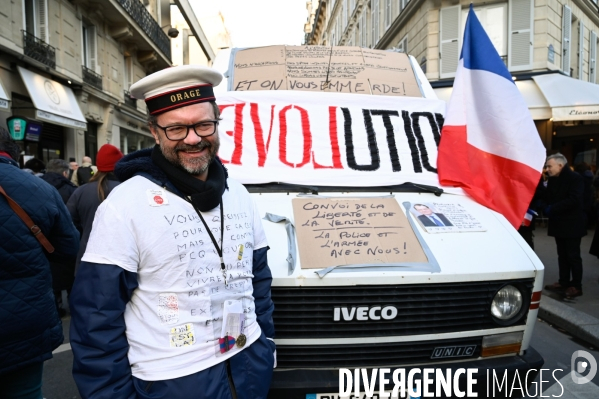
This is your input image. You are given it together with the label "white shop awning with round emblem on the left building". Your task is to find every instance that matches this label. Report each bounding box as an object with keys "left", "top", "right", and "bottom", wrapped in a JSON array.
[{"left": 18, "top": 67, "right": 87, "bottom": 129}]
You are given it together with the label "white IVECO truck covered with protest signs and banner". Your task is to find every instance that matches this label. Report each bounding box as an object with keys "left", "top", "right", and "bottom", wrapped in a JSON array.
[{"left": 217, "top": 46, "right": 543, "bottom": 399}]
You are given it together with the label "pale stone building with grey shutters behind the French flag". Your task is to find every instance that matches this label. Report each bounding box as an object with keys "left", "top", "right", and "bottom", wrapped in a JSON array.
[{"left": 306, "top": 0, "right": 599, "bottom": 166}]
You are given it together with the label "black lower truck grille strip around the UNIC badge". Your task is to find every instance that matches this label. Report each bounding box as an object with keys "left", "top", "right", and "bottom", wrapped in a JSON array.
[{"left": 277, "top": 337, "right": 482, "bottom": 369}]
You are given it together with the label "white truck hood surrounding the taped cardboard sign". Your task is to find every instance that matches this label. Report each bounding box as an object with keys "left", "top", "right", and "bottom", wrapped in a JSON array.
[{"left": 252, "top": 192, "right": 543, "bottom": 286}]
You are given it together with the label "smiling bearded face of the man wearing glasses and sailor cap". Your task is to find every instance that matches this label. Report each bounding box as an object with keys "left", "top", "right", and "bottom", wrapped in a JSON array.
[{"left": 151, "top": 102, "right": 220, "bottom": 180}]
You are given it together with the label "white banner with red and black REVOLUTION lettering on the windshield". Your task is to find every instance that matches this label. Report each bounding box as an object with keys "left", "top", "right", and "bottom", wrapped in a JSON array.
[{"left": 217, "top": 91, "right": 452, "bottom": 191}]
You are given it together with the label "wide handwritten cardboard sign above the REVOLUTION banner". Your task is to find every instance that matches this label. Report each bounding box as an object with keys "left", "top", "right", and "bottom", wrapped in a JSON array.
[{"left": 232, "top": 46, "right": 422, "bottom": 97}]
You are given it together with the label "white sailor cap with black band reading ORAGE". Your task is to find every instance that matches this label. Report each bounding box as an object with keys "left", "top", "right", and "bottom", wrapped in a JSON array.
[{"left": 131, "top": 65, "right": 223, "bottom": 115}]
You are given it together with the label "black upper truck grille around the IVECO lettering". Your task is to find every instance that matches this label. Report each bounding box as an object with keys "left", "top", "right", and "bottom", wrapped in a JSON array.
[{"left": 272, "top": 279, "right": 533, "bottom": 339}]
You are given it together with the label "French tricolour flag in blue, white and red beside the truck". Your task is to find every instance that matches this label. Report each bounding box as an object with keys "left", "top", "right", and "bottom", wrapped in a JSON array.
[{"left": 437, "top": 5, "right": 545, "bottom": 228}]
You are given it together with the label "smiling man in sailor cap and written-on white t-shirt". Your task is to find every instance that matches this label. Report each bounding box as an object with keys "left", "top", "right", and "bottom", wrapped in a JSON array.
[{"left": 70, "top": 65, "right": 276, "bottom": 399}]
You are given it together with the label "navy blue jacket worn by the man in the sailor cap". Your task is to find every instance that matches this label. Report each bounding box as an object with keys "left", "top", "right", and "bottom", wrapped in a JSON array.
[{"left": 70, "top": 149, "right": 275, "bottom": 399}]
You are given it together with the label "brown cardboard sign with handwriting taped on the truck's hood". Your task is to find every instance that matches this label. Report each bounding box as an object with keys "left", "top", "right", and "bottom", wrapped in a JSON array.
[{"left": 292, "top": 197, "right": 428, "bottom": 269}]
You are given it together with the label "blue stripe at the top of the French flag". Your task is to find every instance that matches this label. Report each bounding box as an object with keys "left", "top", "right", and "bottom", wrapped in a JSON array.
[{"left": 460, "top": 4, "right": 514, "bottom": 84}]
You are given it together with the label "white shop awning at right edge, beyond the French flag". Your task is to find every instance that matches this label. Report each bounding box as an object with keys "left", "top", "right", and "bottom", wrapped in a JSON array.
[{"left": 533, "top": 73, "right": 599, "bottom": 122}]
